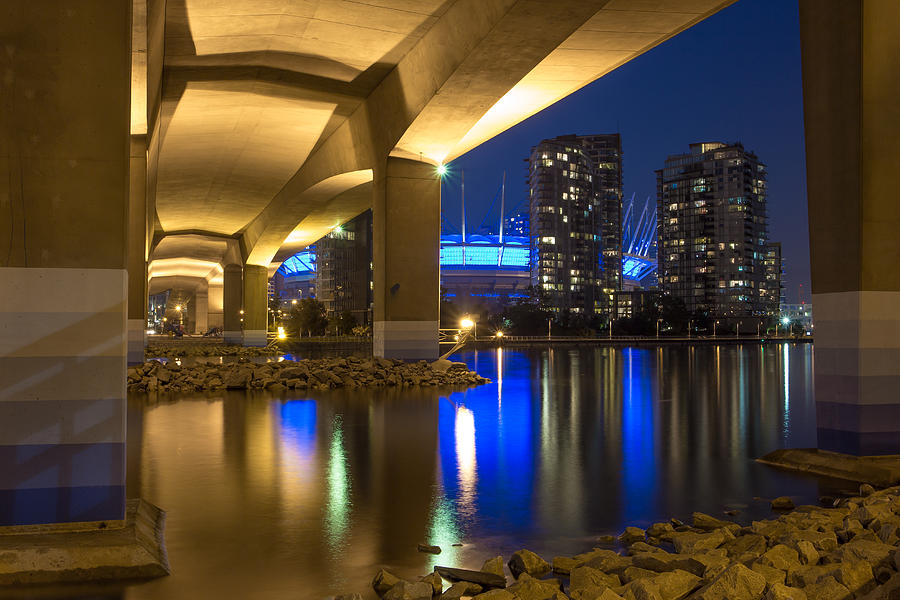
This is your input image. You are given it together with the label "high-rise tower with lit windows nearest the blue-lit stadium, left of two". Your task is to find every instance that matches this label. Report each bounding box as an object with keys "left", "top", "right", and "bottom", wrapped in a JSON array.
[{"left": 528, "top": 134, "right": 622, "bottom": 317}]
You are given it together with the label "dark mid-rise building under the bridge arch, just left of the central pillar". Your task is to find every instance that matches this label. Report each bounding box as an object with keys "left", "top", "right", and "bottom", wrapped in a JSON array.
[{"left": 316, "top": 210, "right": 372, "bottom": 324}]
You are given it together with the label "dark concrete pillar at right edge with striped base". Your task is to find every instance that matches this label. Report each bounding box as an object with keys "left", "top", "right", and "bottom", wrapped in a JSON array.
[{"left": 800, "top": 0, "right": 900, "bottom": 454}]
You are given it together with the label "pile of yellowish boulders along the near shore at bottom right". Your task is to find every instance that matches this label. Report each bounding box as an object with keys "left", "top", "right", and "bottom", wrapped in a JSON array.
[{"left": 348, "top": 485, "right": 900, "bottom": 600}]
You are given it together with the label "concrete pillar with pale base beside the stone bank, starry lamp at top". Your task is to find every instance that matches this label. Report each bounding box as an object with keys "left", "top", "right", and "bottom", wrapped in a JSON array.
[{"left": 372, "top": 158, "right": 441, "bottom": 360}]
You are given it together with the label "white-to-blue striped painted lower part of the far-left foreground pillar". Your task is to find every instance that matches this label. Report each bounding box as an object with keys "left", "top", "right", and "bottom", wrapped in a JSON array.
[{"left": 0, "top": 268, "right": 128, "bottom": 525}]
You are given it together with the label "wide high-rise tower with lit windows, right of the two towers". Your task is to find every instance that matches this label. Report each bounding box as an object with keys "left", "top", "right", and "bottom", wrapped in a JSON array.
[{"left": 656, "top": 142, "right": 777, "bottom": 320}]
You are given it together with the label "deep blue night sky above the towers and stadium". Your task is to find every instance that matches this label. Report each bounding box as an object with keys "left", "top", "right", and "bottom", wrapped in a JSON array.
[{"left": 442, "top": 0, "right": 809, "bottom": 302}]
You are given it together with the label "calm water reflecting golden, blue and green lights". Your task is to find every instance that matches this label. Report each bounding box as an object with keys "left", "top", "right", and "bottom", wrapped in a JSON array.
[{"left": 42, "top": 344, "right": 834, "bottom": 600}]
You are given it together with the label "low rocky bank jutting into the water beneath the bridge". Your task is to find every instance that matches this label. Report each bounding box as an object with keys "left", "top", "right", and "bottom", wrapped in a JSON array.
[{"left": 128, "top": 357, "right": 490, "bottom": 392}]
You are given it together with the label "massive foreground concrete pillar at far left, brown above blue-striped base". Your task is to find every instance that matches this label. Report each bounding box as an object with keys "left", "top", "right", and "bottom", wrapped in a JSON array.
[{"left": 0, "top": 0, "right": 131, "bottom": 526}]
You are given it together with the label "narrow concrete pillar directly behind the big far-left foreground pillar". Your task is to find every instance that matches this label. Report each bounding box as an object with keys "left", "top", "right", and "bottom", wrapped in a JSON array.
[{"left": 128, "top": 135, "right": 149, "bottom": 365}]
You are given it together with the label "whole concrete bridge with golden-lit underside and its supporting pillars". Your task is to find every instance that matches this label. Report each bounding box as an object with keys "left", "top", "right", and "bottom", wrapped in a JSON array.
[{"left": 0, "top": 0, "right": 900, "bottom": 525}]
